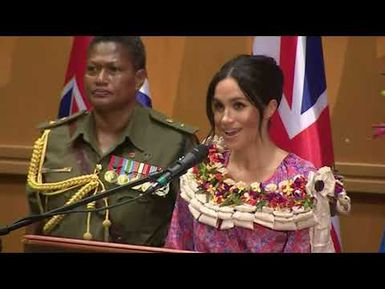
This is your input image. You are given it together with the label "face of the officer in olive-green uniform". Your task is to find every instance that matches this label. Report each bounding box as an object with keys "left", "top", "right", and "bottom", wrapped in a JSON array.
[{"left": 84, "top": 42, "right": 144, "bottom": 111}]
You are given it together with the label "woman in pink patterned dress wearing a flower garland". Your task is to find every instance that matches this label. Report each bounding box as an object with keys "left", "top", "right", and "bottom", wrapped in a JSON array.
[{"left": 165, "top": 55, "right": 350, "bottom": 252}]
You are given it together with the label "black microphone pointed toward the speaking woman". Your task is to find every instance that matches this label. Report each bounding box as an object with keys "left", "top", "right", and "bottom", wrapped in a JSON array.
[{"left": 145, "top": 144, "right": 209, "bottom": 194}]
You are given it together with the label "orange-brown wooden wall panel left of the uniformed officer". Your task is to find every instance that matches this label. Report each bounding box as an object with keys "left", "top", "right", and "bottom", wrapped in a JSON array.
[{"left": 0, "top": 37, "right": 71, "bottom": 145}]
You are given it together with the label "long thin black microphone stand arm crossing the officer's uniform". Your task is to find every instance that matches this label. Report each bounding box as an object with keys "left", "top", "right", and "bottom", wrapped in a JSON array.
[{"left": 0, "top": 171, "right": 163, "bottom": 236}]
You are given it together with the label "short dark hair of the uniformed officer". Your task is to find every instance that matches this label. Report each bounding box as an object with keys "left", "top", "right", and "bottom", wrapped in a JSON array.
[{"left": 87, "top": 36, "right": 146, "bottom": 70}]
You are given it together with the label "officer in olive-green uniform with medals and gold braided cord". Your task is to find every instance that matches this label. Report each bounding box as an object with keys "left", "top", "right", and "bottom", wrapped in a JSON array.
[{"left": 27, "top": 36, "right": 197, "bottom": 246}]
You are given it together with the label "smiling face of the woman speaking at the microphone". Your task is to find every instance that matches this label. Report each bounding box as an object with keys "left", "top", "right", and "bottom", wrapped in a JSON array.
[{"left": 212, "top": 78, "right": 260, "bottom": 150}]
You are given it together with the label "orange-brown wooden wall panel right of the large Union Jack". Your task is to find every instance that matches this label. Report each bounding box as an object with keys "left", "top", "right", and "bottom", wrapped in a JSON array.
[{"left": 324, "top": 37, "right": 385, "bottom": 166}]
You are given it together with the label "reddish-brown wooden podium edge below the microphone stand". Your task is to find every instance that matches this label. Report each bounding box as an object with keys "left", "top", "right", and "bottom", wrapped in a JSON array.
[{"left": 22, "top": 235, "right": 196, "bottom": 253}]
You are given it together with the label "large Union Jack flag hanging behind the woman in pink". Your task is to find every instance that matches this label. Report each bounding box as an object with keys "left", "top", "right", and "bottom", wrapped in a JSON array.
[{"left": 253, "top": 36, "right": 341, "bottom": 252}]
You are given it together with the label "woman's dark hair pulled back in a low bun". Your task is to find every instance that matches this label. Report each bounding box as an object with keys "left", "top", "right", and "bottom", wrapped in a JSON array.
[{"left": 206, "top": 55, "right": 283, "bottom": 135}]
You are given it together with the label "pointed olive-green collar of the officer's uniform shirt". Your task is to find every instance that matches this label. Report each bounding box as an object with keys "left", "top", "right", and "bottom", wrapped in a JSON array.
[{"left": 69, "top": 104, "right": 150, "bottom": 151}]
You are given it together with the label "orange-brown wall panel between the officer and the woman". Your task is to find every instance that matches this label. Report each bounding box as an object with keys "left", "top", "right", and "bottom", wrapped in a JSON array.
[{"left": 173, "top": 37, "right": 250, "bottom": 139}]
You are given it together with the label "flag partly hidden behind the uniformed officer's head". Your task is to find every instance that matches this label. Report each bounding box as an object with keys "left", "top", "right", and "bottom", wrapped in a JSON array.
[{"left": 58, "top": 36, "right": 152, "bottom": 118}]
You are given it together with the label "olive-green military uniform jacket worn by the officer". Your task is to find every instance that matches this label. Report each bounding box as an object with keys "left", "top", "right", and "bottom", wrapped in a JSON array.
[{"left": 27, "top": 105, "right": 197, "bottom": 246}]
